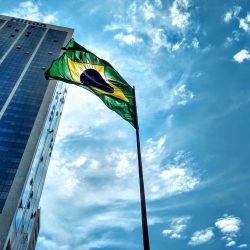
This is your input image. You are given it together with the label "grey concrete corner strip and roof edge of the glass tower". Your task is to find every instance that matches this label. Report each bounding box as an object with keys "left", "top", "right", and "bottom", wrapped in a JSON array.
[{"left": 0, "top": 15, "right": 74, "bottom": 250}]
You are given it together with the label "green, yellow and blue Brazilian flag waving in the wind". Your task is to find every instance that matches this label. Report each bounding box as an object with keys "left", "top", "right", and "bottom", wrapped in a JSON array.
[{"left": 45, "top": 39, "right": 135, "bottom": 127}]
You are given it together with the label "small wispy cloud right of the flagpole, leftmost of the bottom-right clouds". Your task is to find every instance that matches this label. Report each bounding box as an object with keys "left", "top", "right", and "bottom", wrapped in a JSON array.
[{"left": 162, "top": 216, "right": 191, "bottom": 239}]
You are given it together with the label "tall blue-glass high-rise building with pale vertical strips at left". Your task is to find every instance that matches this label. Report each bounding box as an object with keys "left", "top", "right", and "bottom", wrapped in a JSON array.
[{"left": 0, "top": 15, "right": 73, "bottom": 250}]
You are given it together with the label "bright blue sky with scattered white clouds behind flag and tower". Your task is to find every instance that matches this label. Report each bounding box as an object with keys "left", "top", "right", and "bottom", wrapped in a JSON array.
[{"left": 0, "top": 0, "right": 250, "bottom": 250}]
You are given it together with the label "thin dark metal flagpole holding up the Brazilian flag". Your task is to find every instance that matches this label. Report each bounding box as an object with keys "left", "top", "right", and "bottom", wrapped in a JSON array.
[{"left": 133, "top": 87, "right": 150, "bottom": 250}]
